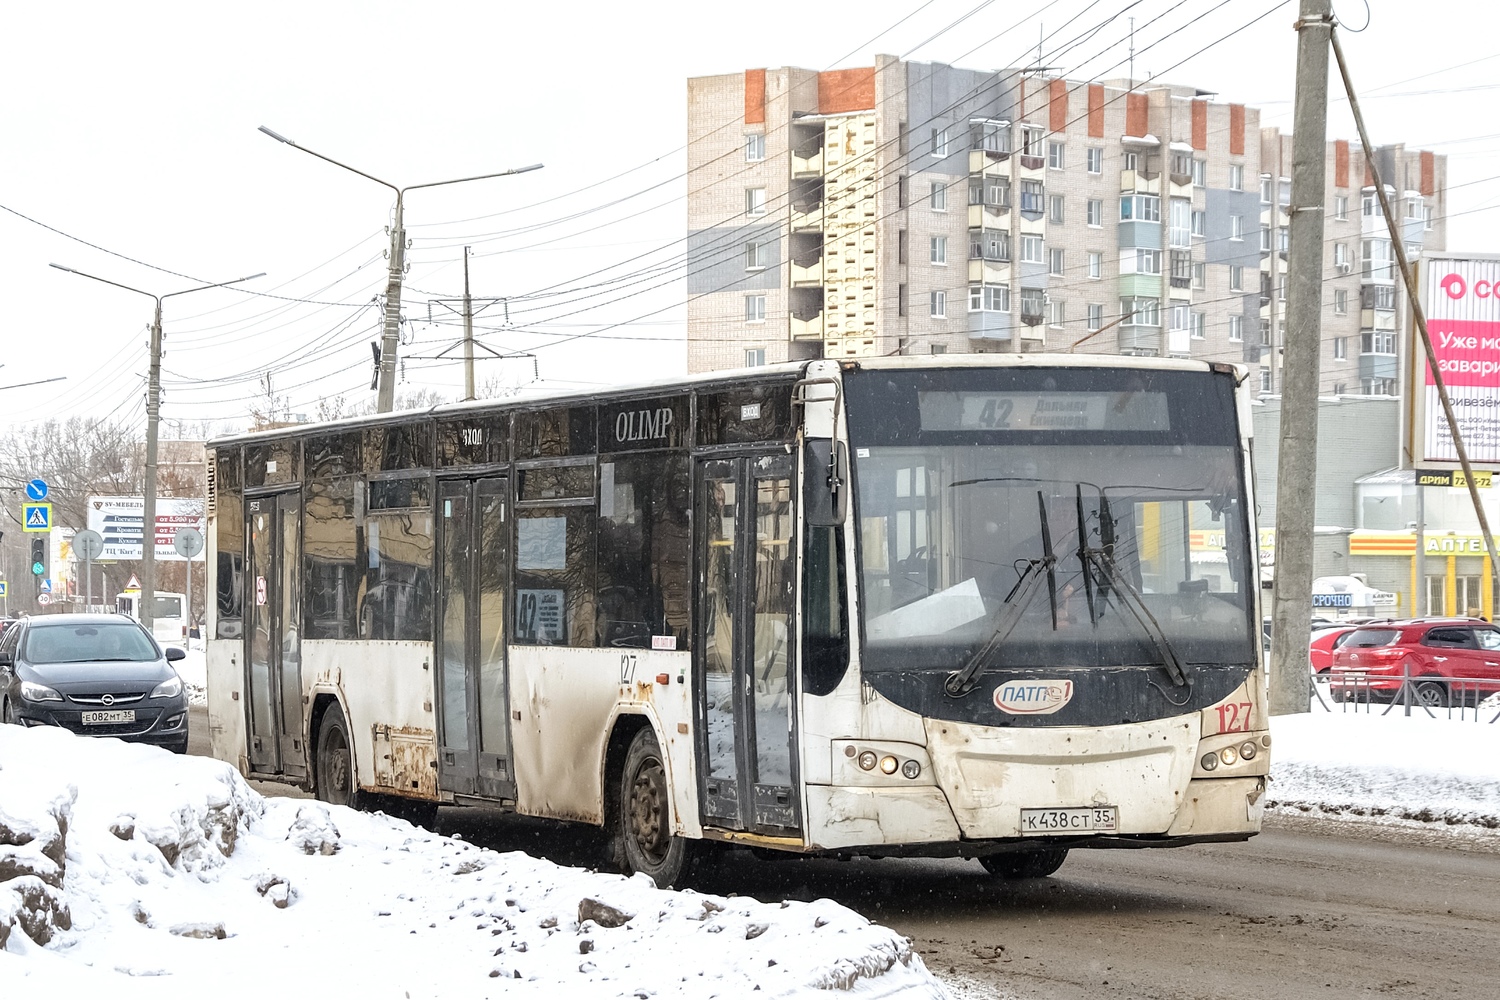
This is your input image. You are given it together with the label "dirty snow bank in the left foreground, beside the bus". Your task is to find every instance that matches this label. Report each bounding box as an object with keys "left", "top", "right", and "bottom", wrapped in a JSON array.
[{"left": 0, "top": 726, "right": 945, "bottom": 1000}]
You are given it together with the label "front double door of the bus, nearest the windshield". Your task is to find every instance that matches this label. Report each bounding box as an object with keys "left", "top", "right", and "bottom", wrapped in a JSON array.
[{"left": 695, "top": 454, "right": 801, "bottom": 835}]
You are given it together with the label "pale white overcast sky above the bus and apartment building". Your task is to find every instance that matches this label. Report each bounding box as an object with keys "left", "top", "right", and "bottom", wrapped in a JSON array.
[{"left": 0, "top": 0, "right": 1500, "bottom": 433}]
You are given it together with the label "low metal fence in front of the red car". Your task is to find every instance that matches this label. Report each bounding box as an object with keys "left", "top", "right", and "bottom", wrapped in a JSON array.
[{"left": 1310, "top": 666, "right": 1500, "bottom": 724}]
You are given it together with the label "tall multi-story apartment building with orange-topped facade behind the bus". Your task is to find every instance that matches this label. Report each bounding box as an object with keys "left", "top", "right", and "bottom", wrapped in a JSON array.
[{"left": 687, "top": 55, "right": 1446, "bottom": 393}]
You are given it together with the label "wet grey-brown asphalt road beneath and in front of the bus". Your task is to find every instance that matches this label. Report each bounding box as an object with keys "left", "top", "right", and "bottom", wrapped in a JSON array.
[{"left": 192, "top": 712, "right": 1500, "bottom": 1000}]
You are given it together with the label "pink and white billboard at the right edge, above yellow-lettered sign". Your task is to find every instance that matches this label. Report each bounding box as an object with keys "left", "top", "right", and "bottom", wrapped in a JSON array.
[{"left": 1407, "top": 253, "right": 1500, "bottom": 468}]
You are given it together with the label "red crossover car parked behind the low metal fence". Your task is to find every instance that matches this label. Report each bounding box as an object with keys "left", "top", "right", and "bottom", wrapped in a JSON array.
[{"left": 1329, "top": 618, "right": 1500, "bottom": 706}]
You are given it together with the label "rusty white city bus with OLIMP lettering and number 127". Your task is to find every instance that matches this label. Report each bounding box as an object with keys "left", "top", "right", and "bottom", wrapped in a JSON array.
[{"left": 207, "top": 355, "right": 1271, "bottom": 885}]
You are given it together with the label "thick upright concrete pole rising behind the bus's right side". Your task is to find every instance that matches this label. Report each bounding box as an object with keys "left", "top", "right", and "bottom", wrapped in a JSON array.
[{"left": 1271, "top": 0, "right": 1334, "bottom": 715}]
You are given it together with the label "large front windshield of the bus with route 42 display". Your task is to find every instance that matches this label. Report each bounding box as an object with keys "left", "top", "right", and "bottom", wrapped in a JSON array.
[{"left": 848, "top": 369, "right": 1256, "bottom": 679}]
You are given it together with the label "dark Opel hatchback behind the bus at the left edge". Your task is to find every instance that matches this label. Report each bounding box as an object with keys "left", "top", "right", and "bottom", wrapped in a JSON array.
[{"left": 0, "top": 615, "right": 188, "bottom": 754}]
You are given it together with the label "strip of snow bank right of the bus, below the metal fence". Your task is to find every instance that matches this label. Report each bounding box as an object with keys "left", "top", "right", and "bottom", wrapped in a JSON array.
[{"left": 1266, "top": 708, "right": 1500, "bottom": 834}]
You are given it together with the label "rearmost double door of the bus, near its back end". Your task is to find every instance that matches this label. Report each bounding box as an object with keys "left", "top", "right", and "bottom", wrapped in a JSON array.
[{"left": 245, "top": 490, "right": 308, "bottom": 778}]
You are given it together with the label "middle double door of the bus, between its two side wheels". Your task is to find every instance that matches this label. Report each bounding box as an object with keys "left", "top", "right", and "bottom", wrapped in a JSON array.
[{"left": 437, "top": 477, "right": 516, "bottom": 799}]
